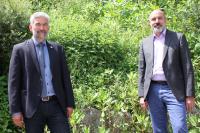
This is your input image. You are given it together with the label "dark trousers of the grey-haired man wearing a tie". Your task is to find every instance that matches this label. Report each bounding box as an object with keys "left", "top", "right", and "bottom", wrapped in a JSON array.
[{"left": 24, "top": 100, "right": 70, "bottom": 133}]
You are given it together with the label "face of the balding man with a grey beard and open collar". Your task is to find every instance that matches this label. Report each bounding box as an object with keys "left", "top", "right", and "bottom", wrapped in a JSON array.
[{"left": 149, "top": 10, "right": 166, "bottom": 34}]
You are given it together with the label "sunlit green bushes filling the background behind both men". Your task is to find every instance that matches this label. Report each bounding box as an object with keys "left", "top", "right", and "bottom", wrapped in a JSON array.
[{"left": 0, "top": 0, "right": 200, "bottom": 133}]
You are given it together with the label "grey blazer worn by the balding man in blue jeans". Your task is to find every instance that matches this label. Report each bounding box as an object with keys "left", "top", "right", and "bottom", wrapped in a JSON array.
[{"left": 138, "top": 30, "right": 194, "bottom": 100}]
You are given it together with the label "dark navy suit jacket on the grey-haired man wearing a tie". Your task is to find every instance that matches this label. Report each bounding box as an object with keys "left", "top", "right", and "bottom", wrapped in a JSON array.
[{"left": 8, "top": 39, "right": 75, "bottom": 118}]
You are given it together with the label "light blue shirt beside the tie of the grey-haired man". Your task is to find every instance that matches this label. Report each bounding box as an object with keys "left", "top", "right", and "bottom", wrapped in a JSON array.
[{"left": 32, "top": 37, "right": 55, "bottom": 96}]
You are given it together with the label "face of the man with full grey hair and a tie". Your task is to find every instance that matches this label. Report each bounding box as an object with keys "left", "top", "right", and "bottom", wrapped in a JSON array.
[{"left": 29, "top": 17, "right": 49, "bottom": 42}]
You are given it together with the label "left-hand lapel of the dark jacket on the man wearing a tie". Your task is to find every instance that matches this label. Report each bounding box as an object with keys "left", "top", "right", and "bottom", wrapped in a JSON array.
[{"left": 27, "top": 39, "right": 40, "bottom": 72}]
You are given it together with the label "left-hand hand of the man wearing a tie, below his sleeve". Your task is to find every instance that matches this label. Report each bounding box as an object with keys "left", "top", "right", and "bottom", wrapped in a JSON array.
[{"left": 12, "top": 113, "right": 24, "bottom": 127}]
